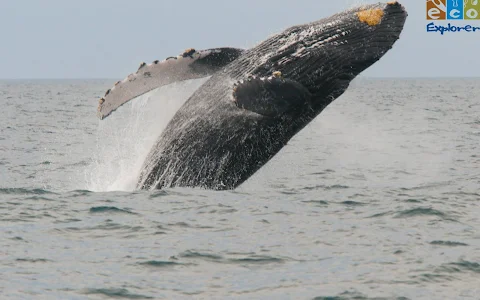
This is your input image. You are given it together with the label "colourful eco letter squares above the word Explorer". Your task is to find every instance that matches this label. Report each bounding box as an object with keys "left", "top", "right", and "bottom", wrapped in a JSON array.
[{"left": 427, "top": 0, "right": 480, "bottom": 21}]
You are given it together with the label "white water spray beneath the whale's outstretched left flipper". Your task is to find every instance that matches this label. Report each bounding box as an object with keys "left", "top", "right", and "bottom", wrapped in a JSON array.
[{"left": 85, "top": 77, "right": 208, "bottom": 192}]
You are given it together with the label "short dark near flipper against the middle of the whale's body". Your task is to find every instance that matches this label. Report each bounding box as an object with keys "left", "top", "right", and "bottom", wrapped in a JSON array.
[{"left": 233, "top": 72, "right": 311, "bottom": 117}]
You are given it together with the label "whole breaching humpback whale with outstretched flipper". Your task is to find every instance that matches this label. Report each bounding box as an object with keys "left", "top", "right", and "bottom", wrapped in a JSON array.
[{"left": 98, "top": 1, "right": 407, "bottom": 190}]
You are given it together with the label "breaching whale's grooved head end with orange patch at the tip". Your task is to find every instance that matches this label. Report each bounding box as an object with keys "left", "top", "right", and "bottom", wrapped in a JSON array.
[{"left": 246, "top": 1, "right": 407, "bottom": 112}]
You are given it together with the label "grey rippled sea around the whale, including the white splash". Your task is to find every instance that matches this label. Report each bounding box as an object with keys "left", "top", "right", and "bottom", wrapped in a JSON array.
[{"left": 0, "top": 78, "right": 480, "bottom": 300}]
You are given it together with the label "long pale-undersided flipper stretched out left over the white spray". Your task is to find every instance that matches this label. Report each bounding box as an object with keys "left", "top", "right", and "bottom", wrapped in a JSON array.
[{"left": 97, "top": 48, "right": 244, "bottom": 119}]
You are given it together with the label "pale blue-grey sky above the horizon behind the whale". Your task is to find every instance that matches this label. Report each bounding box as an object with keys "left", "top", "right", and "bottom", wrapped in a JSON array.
[{"left": 0, "top": 0, "right": 480, "bottom": 79}]
